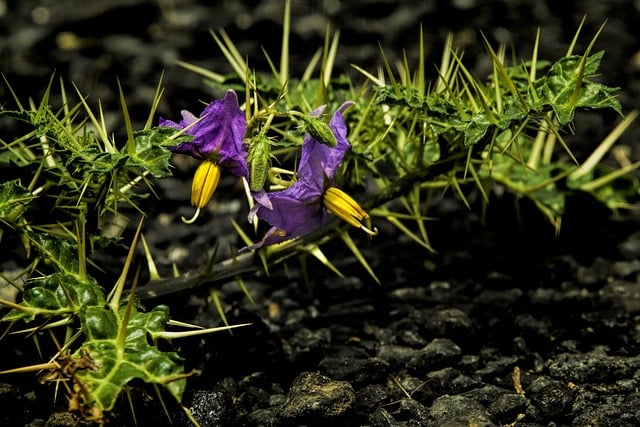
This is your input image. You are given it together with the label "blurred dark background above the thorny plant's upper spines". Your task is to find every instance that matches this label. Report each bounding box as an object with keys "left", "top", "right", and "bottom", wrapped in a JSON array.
[{"left": 0, "top": 0, "right": 640, "bottom": 120}]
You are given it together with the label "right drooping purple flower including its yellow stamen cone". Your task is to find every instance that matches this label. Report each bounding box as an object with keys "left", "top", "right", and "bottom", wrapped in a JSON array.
[{"left": 246, "top": 102, "right": 376, "bottom": 249}]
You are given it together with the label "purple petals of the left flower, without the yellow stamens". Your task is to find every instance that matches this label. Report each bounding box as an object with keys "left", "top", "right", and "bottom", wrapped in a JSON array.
[{"left": 159, "top": 90, "right": 248, "bottom": 177}]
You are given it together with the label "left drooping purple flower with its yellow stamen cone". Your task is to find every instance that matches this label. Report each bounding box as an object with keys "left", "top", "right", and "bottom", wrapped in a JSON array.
[{"left": 159, "top": 90, "right": 248, "bottom": 222}]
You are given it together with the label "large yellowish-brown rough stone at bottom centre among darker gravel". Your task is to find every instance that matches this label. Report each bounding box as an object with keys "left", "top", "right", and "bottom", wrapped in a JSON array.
[{"left": 278, "top": 372, "right": 356, "bottom": 425}]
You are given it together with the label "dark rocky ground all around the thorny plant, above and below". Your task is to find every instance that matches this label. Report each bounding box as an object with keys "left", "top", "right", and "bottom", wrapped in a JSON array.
[{"left": 0, "top": 0, "right": 640, "bottom": 426}]
